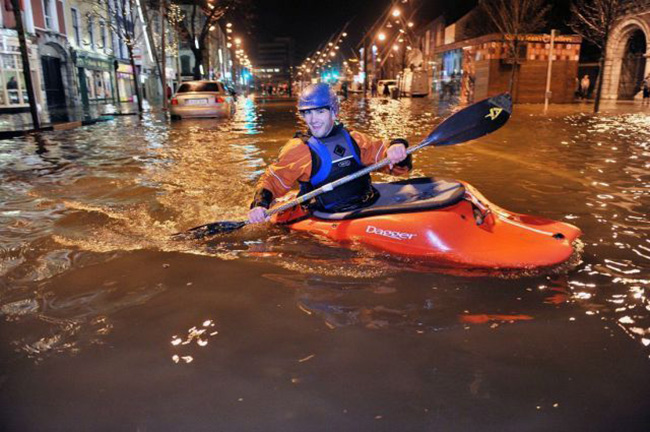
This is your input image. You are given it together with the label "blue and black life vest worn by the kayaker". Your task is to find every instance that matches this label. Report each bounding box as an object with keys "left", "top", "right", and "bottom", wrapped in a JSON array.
[{"left": 300, "top": 125, "right": 378, "bottom": 212}]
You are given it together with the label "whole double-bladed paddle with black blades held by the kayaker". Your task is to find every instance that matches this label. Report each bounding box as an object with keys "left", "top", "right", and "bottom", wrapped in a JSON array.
[{"left": 173, "top": 93, "right": 512, "bottom": 240}]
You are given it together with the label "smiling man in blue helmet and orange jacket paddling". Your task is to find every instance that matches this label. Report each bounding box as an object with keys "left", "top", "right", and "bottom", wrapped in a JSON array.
[{"left": 248, "top": 83, "right": 412, "bottom": 223}]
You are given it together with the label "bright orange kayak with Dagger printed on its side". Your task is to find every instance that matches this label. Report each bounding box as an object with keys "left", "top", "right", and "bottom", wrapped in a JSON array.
[{"left": 274, "top": 178, "right": 581, "bottom": 269}]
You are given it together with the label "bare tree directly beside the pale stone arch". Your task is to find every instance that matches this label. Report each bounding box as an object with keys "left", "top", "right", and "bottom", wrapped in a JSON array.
[{"left": 569, "top": 0, "right": 648, "bottom": 113}]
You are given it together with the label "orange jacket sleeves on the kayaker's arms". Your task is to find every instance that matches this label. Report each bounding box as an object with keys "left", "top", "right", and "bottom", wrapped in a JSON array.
[{"left": 257, "top": 131, "right": 409, "bottom": 202}]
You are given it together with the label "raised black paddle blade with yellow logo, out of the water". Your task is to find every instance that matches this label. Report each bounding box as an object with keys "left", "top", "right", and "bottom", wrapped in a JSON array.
[{"left": 425, "top": 93, "right": 512, "bottom": 146}]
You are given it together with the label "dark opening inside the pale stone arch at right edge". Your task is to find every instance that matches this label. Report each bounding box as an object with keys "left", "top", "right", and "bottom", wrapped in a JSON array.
[{"left": 618, "top": 29, "right": 647, "bottom": 99}]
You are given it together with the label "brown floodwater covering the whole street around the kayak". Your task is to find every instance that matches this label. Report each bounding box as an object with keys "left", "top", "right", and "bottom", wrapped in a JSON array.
[{"left": 0, "top": 98, "right": 650, "bottom": 431}]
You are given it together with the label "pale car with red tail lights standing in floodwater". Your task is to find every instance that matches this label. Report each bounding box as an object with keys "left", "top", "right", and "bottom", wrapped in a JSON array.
[{"left": 170, "top": 81, "right": 235, "bottom": 119}]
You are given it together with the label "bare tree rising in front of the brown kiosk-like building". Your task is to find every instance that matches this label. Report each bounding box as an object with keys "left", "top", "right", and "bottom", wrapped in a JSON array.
[{"left": 480, "top": 0, "right": 548, "bottom": 94}]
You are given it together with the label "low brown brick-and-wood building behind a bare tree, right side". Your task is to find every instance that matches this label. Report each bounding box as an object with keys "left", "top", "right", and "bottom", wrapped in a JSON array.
[{"left": 420, "top": 11, "right": 582, "bottom": 103}]
